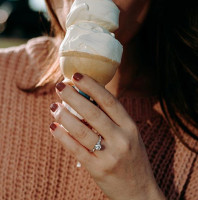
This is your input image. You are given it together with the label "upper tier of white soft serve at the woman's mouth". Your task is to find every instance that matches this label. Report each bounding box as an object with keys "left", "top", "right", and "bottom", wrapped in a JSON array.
[{"left": 66, "top": 0, "right": 120, "bottom": 32}]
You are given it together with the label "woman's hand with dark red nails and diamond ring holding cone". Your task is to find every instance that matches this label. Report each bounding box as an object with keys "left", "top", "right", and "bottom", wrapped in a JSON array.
[{"left": 51, "top": 73, "right": 165, "bottom": 200}]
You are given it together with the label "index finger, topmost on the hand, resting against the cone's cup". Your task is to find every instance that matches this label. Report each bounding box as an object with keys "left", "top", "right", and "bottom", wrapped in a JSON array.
[{"left": 72, "top": 73, "right": 131, "bottom": 126}]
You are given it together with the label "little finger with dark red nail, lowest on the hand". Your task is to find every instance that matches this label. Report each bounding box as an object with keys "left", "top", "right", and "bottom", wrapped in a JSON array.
[{"left": 50, "top": 123, "right": 96, "bottom": 167}]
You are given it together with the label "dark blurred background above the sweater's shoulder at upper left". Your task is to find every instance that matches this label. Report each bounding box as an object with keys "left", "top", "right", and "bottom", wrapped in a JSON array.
[{"left": 0, "top": 0, "right": 50, "bottom": 48}]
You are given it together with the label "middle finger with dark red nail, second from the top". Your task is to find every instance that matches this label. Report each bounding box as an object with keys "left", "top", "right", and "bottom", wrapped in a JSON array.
[{"left": 57, "top": 82, "right": 116, "bottom": 138}]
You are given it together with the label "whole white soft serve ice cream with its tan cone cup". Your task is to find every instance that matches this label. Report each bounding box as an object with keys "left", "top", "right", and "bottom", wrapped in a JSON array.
[{"left": 60, "top": 0, "right": 123, "bottom": 86}]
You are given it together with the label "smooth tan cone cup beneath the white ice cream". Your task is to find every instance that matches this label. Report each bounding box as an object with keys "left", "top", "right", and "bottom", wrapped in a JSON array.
[{"left": 60, "top": 51, "right": 119, "bottom": 86}]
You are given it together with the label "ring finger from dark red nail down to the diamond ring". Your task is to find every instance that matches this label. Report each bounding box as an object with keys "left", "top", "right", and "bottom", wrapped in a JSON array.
[{"left": 51, "top": 103, "right": 102, "bottom": 150}]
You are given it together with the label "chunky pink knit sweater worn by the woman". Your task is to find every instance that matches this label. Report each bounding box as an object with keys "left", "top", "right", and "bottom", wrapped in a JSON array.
[{"left": 0, "top": 37, "right": 198, "bottom": 200}]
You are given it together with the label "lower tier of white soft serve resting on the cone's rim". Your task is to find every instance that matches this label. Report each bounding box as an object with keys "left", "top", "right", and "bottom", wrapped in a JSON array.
[{"left": 60, "top": 22, "right": 122, "bottom": 63}]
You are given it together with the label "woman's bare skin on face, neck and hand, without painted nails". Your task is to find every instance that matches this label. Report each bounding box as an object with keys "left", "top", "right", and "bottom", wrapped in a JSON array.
[{"left": 50, "top": 0, "right": 165, "bottom": 200}]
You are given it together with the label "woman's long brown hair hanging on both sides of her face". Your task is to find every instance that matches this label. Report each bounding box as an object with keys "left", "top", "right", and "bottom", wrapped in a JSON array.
[{"left": 29, "top": 0, "right": 198, "bottom": 145}]
